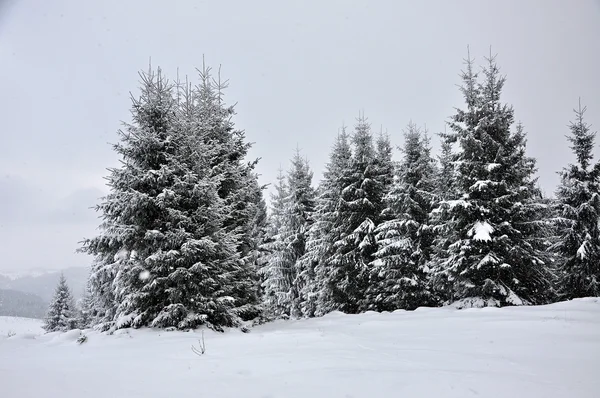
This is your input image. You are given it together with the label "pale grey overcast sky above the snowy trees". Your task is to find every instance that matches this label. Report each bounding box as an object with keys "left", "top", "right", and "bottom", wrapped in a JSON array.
[{"left": 0, "top": 0, "right": 600, "bottom": 271}]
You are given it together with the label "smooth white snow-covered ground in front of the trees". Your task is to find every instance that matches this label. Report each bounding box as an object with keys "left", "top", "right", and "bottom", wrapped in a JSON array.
[{"left": 0, "top": 299, "right": 600, "bottom": 398}]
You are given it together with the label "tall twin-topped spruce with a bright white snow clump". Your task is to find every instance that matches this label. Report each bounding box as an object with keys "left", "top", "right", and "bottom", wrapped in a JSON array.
[{"left": 434, "top": 52, "right": 552, "bottom": 306}]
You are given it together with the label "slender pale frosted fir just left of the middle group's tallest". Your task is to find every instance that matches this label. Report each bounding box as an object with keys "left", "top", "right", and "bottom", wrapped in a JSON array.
[{"left": 299, "top": 127, "right": 352, "bottom": 317}]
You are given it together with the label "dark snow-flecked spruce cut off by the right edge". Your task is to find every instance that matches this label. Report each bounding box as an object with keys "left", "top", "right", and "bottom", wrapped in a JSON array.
[{"left": 553, "top": 102, "right": 600, "bottom": 298}]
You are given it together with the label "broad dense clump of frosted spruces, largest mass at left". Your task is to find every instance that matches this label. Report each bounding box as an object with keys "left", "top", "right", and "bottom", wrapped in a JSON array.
[{"left": 83, "top": 68, "right": 261, "bottom": 329}]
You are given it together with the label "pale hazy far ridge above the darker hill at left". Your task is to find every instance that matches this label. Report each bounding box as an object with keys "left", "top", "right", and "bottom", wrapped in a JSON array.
[{"left": 0, "top": 267, "right": 90, "bottom": 302}]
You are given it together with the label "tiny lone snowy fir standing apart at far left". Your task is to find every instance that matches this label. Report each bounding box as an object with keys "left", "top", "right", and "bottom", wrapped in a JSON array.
[{"left": 43, "top": 274, "right": 77, "bottom": 332}]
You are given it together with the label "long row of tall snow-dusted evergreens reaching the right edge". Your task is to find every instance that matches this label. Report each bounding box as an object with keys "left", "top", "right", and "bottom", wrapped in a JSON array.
[{"left": 43, "top": 50, "right": 600, "bottom": 330}]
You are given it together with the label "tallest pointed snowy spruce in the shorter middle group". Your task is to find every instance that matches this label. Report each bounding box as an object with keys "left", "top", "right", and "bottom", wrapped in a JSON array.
[{"left": 325, "top": 116, "right": 387, "bottom": 313}]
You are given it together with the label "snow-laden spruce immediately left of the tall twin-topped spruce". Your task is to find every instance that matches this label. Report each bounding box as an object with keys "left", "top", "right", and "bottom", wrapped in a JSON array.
[{"left": 367, "top": 123, "right": 435, "bottom": 311}]
